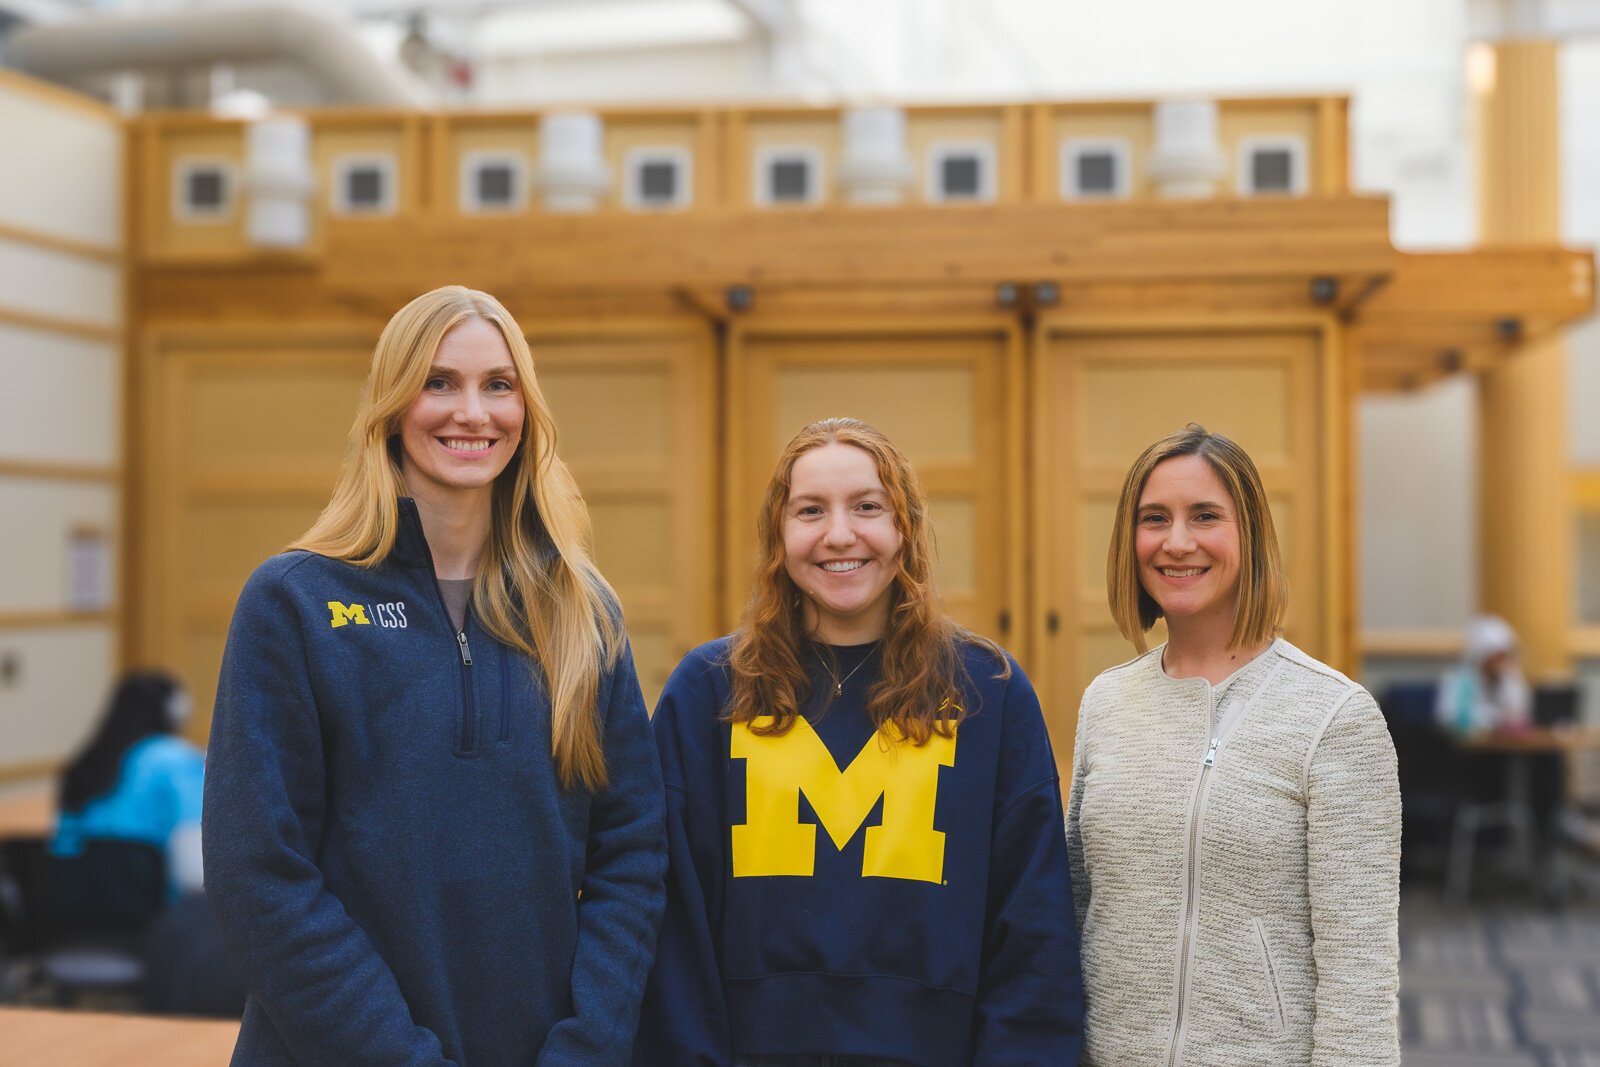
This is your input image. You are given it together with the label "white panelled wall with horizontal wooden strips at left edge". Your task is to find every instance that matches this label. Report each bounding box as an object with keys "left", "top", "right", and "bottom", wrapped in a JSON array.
[{"left": 0, "top": 70, "right": 126, "bottom": 787}]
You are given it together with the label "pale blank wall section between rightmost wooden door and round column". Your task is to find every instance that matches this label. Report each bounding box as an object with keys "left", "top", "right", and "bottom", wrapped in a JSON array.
[{"left": 1357, "top": 378, "right": 1478, "bottom": 630}]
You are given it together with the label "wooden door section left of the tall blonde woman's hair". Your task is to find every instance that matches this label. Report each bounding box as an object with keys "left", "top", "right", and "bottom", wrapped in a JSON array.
[{"left": 131, "top": 326, "right": 374, "bottom": 741}]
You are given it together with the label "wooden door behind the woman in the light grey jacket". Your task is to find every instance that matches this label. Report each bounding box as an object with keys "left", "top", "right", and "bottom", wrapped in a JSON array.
[{"left": 1032, "top": 318, "right": 1347, "bottom": 780}]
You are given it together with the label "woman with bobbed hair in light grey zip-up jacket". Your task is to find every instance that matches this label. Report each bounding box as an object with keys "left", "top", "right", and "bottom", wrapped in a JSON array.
[{"left": 1067, "top": 424, "right": 1400, "bottom": 1067}]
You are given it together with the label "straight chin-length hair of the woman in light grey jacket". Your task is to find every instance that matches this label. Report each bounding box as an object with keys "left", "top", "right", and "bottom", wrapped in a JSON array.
[{"left": 1106, "top": 422, "right": 1288, "bottom": 653}]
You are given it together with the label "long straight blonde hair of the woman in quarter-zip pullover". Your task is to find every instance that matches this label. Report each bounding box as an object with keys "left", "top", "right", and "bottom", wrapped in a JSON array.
[{"left": 290, "top": 285, "right": 622, "bottom": 790}]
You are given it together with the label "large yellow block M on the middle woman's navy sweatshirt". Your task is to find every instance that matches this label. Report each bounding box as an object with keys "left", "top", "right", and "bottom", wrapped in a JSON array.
[{"left": 733, "top": 715, "right": 955, "bottom": 881}]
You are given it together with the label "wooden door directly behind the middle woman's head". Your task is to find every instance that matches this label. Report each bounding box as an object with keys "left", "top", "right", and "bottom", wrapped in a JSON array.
[{"left": 723, "top": 322, "right": 1021, "bottom": 643}]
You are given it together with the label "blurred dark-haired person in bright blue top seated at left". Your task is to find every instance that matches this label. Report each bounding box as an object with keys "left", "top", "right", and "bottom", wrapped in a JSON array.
[{"left": 50, "top": 670, "right": 205, "bottom": 899}]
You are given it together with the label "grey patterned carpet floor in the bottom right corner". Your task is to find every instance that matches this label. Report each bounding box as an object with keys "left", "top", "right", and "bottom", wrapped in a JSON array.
[{"left": 1400, "top": 891, "right": 1600, "bottom": 1067}]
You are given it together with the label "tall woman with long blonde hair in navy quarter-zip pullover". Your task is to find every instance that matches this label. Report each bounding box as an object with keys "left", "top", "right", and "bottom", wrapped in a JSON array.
[{"left": 205, "top": 286, "right": 666, "bottom": 1067}]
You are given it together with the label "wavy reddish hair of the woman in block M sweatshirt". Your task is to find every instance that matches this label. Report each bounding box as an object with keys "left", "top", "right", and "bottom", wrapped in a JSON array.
[{"left": 726, "top": 419, "right": 1011, "bottom": 745}]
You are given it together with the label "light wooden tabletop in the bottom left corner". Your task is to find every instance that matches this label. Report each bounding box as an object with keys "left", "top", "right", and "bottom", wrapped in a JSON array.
[{"left": 0, "top": 1008, "right": 238, "bottom": 1067}]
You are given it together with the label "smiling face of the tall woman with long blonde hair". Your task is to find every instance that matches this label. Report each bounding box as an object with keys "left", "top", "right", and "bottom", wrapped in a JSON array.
[{"left": 400, "top": 318, "right": 523, "bottom": 506}]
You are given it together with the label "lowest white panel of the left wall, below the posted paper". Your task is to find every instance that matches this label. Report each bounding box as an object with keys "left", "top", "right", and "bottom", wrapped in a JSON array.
[{"left": 0, "top": 624, "right": 117, "bottom": 766}]
